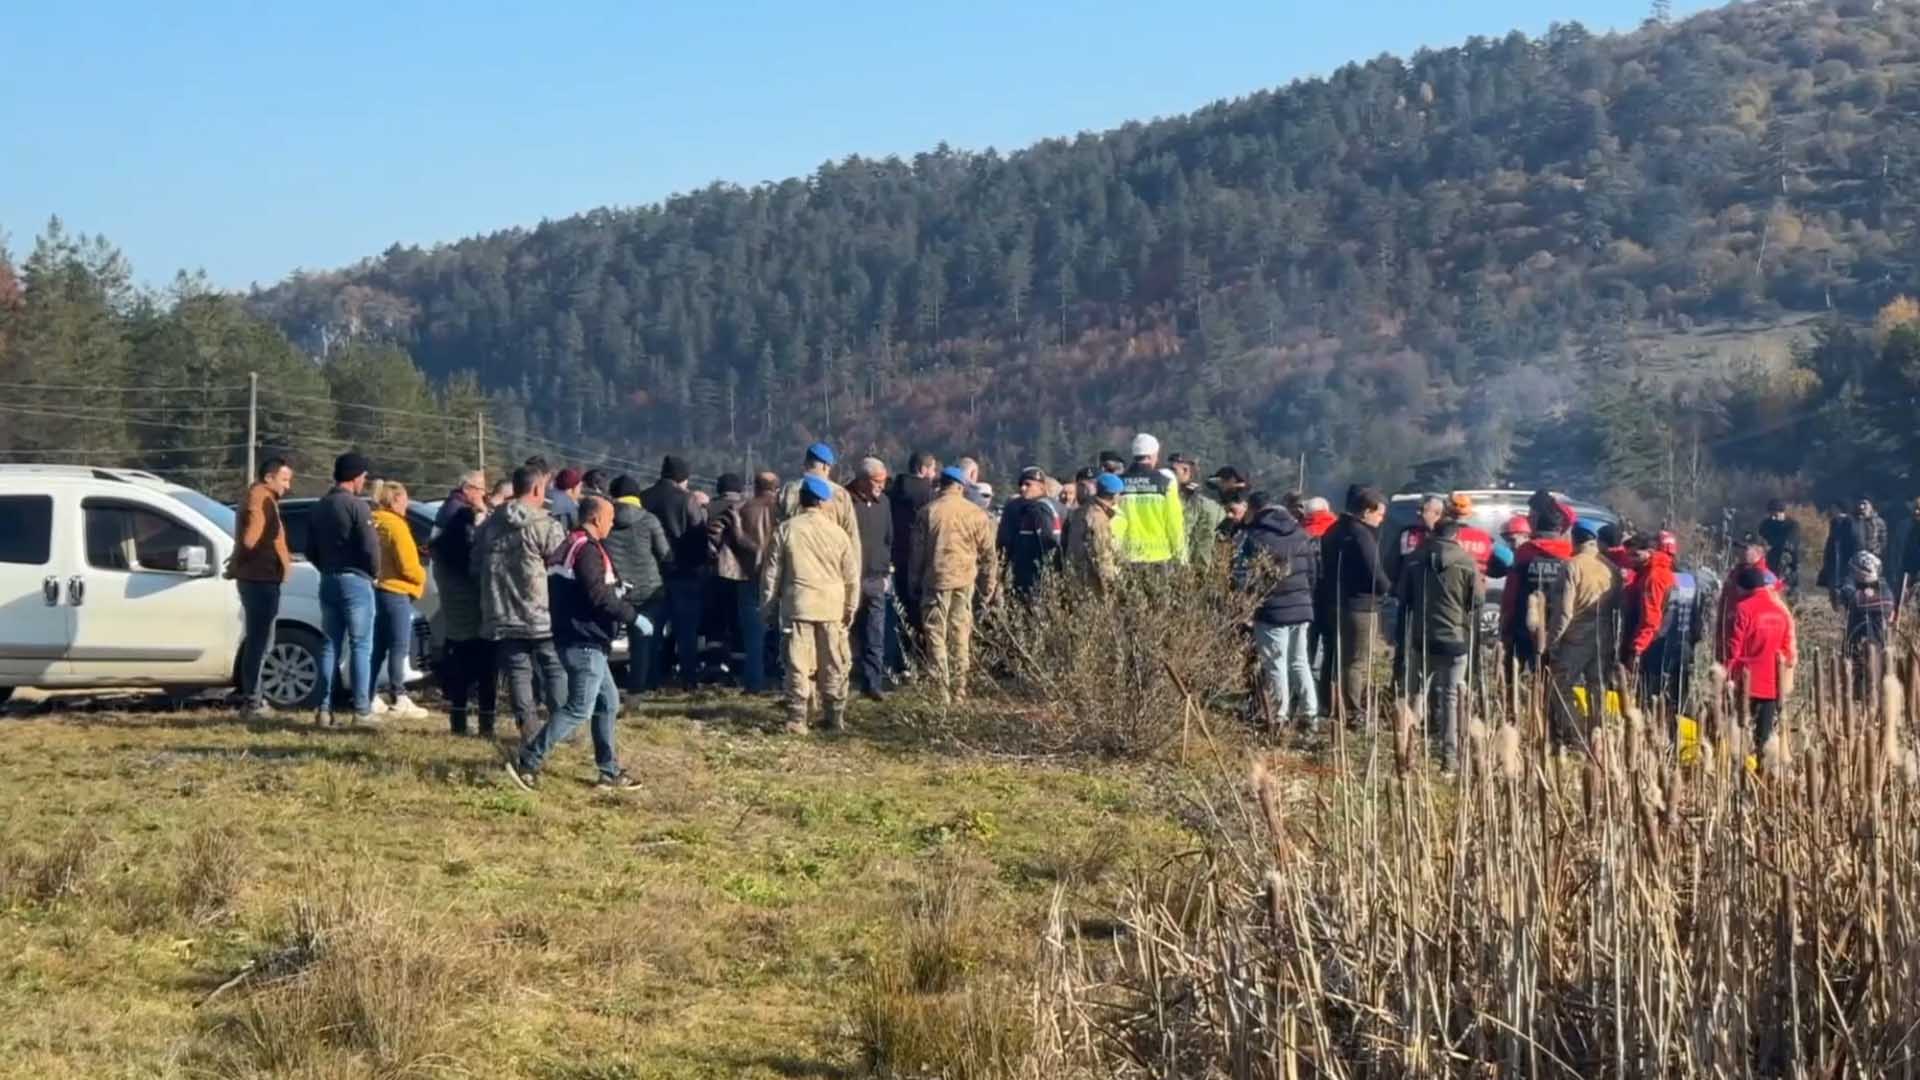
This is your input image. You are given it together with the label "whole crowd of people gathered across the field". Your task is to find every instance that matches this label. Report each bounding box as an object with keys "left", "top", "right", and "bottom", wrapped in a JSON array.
[{"left": 228, "top": 434, "right": 1920, "bottom": 790}]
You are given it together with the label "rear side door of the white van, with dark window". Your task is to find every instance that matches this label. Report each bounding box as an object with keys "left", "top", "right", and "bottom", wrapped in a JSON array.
[{"left": 0, "top": 494, "right": 79, "bottom": 686}]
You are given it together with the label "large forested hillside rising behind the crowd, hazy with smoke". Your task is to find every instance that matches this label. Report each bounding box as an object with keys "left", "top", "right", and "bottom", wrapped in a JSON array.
[{"left": 3, "top": 0, "right": 1920, "bottom": 502}]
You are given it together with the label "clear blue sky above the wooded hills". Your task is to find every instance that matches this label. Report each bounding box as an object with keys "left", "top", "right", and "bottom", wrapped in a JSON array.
[{"left": 0, "top": 0, "right": 1705, "bottom": 288}]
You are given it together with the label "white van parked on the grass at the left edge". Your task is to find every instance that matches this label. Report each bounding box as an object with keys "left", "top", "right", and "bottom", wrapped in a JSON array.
[{"left": 0, "top": 465, "right": 428, "bottom": 709}]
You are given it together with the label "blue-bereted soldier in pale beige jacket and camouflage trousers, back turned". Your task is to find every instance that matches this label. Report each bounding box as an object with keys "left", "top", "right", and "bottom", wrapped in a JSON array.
[{"left": 760, "top": 477, "right": 860, "bottom": 734}]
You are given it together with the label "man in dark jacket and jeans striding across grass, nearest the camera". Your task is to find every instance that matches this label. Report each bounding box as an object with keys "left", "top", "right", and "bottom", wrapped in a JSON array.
[{"left": 507, "top": 496, "right": 639, "bottom": 792}]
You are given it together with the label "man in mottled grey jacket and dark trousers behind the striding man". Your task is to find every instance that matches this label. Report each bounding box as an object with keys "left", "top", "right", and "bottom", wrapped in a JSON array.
[{"left": 472, "top": 465, "right": 566, "bottom": 740}]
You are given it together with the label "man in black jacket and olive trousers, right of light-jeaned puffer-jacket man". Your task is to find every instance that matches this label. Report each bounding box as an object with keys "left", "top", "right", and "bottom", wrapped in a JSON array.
[{"left": 1319, "top": 486, "right": 1394, "bottom": 724}]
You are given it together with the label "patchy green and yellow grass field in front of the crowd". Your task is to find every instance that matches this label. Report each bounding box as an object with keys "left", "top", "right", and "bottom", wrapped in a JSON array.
[{"left": 0, "top": 694, "right": 1192, "bottom": 1080}]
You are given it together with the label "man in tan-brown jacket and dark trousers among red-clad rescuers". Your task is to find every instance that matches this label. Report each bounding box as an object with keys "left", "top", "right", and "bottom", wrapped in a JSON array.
[{"left": 1548, "top": 527, "right": 1620, "bottom": 749}]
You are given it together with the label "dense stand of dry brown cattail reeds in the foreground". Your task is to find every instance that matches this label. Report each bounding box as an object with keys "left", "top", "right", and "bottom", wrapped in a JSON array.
[{"left": 1035, "top": 641, "right": 1920, "bottom": 1080}]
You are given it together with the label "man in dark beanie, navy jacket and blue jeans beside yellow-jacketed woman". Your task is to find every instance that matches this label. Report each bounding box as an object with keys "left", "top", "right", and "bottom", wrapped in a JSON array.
[{"left": 307, "top": 450, "right": 380, "bottom": 726}]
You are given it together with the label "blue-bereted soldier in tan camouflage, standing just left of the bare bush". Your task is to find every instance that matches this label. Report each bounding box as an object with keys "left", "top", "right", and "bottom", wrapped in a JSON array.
[{"left": 912, "top": 467, "right": 1000, "bottom": 701}]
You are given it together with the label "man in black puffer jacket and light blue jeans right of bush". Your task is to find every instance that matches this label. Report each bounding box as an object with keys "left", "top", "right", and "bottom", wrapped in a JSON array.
[{"left": 1235, "top": 492, "right": 1321, "bottom": 728}]
